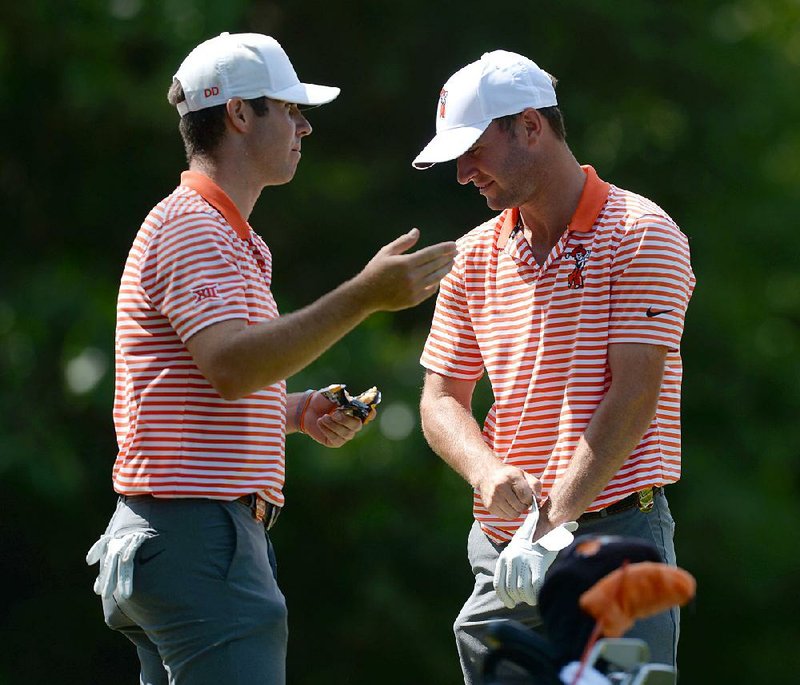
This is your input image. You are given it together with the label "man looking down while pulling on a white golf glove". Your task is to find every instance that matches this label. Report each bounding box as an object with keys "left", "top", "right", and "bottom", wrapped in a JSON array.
[{"left": 414, "top": 50, "right": 694, "bottom": 683}]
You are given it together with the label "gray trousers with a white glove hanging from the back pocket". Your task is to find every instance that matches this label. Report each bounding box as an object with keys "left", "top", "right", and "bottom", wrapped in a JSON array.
[{"left": 103, "top": 496, "right": 287, "bottom": 685}]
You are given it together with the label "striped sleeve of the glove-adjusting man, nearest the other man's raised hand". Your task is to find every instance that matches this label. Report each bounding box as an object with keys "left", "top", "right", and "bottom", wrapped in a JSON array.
[{"left": 420, "top": 256, "right": 483, "bottom": 381}]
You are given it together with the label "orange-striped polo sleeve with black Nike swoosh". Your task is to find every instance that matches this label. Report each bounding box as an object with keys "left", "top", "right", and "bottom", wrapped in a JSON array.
[{"left": 609, "top": 214, "right": 695, "bottom": 350}]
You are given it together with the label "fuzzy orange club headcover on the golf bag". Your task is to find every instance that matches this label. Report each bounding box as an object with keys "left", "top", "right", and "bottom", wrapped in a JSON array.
[{"left": 579, "top": 561, "right": 697, "bottom": 637}]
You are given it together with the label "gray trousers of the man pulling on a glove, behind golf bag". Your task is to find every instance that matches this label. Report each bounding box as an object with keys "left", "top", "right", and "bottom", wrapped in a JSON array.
[{"left": 453, "top": 490, "right": 680, "bottom": 685}]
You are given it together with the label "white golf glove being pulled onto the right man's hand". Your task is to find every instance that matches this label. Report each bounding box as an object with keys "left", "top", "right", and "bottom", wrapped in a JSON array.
[{"left": 494, "top": 501, "right": 578, "bottom": 609}]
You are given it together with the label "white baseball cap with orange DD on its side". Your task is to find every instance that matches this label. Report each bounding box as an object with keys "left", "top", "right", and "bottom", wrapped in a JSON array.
[{"left": 175, "top": 31, "right": 340, "bottom": 116}]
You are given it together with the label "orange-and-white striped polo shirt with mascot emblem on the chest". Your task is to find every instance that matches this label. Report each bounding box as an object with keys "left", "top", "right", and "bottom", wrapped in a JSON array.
[{"left": 421, "top": 167, "right": 695, "bottom": 541}]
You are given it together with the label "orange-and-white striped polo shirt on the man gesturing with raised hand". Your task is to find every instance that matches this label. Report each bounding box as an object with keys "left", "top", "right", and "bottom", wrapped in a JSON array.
[{"left": 113, "top": 171, "right": 286, "bottom": 505}]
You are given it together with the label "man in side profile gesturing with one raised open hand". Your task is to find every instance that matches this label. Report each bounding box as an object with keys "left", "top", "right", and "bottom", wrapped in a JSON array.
[{"left": 87, "top": 33, "right": 455, "bottom": 685}]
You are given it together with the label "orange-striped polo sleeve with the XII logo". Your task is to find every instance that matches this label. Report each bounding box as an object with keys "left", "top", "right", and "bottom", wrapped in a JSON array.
[{"left": 142, "top": 213, "right": 248, "bottom": 343}]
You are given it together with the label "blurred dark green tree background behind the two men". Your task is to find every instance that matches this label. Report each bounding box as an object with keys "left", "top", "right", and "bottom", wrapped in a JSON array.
[{"left": 0, "top": 0, "right": 800, "bottom": 685}]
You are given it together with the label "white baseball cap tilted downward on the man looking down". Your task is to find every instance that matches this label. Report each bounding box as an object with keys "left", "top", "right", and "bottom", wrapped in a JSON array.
[{"left": 413, "top": 50, "right": 558, "bottom": 169}]
